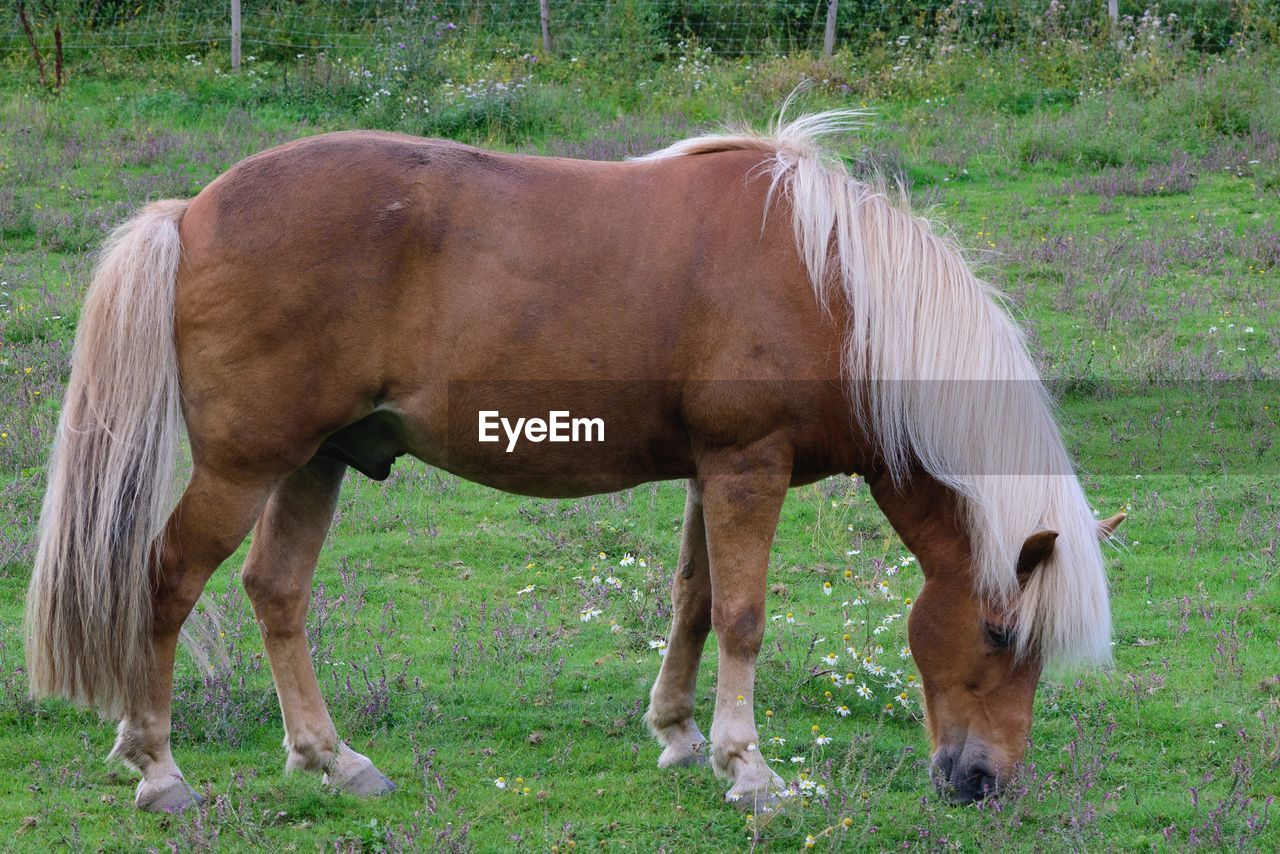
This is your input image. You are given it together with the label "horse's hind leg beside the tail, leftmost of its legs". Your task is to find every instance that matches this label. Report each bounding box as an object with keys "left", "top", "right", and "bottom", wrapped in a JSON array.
[{"left": 111, "top": 463, "right": 275, "bottom": 812}]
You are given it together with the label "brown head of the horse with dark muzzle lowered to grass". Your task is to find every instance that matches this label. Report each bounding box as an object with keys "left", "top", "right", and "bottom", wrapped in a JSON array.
[{"left": 909, "top": 513, "right": 1124, "bottom": 803}]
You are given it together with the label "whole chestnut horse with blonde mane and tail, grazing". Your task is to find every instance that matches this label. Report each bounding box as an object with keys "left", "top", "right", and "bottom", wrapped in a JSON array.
[{"left": 27, "top": 111, "right": 1119, "bottom": 810}]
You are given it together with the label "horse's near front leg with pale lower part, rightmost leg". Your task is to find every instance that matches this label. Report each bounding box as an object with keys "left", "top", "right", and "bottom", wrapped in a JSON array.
[{"left": 699, "top": 453, "right": 791, "bottom": 812}]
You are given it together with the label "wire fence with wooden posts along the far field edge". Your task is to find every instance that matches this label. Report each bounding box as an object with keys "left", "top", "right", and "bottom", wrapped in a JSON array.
[{"left": 0, "top": 0, "right": 1280, "bottom": 61}]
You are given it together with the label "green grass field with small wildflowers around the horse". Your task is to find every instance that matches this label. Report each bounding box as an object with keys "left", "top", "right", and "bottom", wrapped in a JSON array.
[{"left": 0, "top": 16, "right": 1280, "bottom": 851}]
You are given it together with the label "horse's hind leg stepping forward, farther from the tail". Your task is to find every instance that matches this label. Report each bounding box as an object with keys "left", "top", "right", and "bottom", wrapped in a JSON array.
[{"left": 243, "top": 457, "right": 396, "bottom": 795}]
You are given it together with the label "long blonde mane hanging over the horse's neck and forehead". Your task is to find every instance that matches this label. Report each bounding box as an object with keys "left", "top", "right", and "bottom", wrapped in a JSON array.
[{"left": 646, "top": 106, "right": 1111, "bottom": 666}]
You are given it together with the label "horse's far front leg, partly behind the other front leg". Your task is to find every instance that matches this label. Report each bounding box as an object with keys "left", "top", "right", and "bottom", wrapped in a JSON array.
[{"left": 645, "top": 483, "right": 712, "bottom": 768}]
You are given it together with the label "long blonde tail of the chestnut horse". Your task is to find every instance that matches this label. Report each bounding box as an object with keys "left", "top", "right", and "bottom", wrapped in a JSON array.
[{"left": 26, "top": 201, "right": 189, "bottom": 717}]
